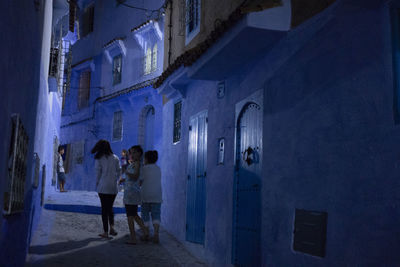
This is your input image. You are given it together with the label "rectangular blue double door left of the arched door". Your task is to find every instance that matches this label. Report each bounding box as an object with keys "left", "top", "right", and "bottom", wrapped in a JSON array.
[{"left": 186, "top": 111, "right": 208, "bottom": 244}]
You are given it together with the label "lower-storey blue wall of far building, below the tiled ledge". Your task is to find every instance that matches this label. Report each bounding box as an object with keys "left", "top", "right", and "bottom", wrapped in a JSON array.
[{"left": 61, "top": 87, "right": 162, "bottom": 190}]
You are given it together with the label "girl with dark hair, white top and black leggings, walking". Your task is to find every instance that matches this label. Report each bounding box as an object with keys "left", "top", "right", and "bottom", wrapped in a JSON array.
[{"left": 91, "top": 140, "right": 121, "bottom": 238}]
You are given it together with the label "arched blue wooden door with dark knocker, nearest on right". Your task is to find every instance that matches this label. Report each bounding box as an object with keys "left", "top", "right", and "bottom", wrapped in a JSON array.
[{"left": 232, "top": 102, "right": 262, "bottom": 266}]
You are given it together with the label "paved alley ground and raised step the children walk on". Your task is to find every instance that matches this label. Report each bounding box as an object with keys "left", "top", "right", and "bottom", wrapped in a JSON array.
[{"left": 26, "top": 191, "right": 206, "bottom": 267}]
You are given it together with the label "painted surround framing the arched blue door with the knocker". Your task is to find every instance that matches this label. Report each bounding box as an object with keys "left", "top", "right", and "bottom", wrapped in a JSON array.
[{"left": 231, "top": 89, "right": 264, "bottom": 264}]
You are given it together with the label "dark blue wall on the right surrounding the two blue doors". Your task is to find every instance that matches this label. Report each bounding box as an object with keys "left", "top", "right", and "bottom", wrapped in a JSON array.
[{"left": 161, "top": 0, "right": 400, "bottom": 266}]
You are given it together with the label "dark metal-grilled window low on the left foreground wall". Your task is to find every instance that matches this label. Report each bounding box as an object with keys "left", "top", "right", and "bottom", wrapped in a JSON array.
[{"left": 3, "top": 114, "right": 29, "bottom": 214}]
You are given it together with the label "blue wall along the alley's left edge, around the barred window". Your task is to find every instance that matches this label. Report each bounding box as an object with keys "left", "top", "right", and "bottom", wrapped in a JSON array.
[{"left": 0, "top": 1, "right": 61, "bottom": 266}]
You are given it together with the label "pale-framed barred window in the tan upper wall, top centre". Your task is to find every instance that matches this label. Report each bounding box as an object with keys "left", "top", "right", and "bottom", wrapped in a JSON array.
[{"left": 186, "top": 0, "right": 201, "bottom": 44}]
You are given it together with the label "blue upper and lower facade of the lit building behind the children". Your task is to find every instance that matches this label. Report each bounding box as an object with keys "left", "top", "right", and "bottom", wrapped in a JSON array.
[{"left": 60, "top": 1, "right": 164, "bottom": 190}]
